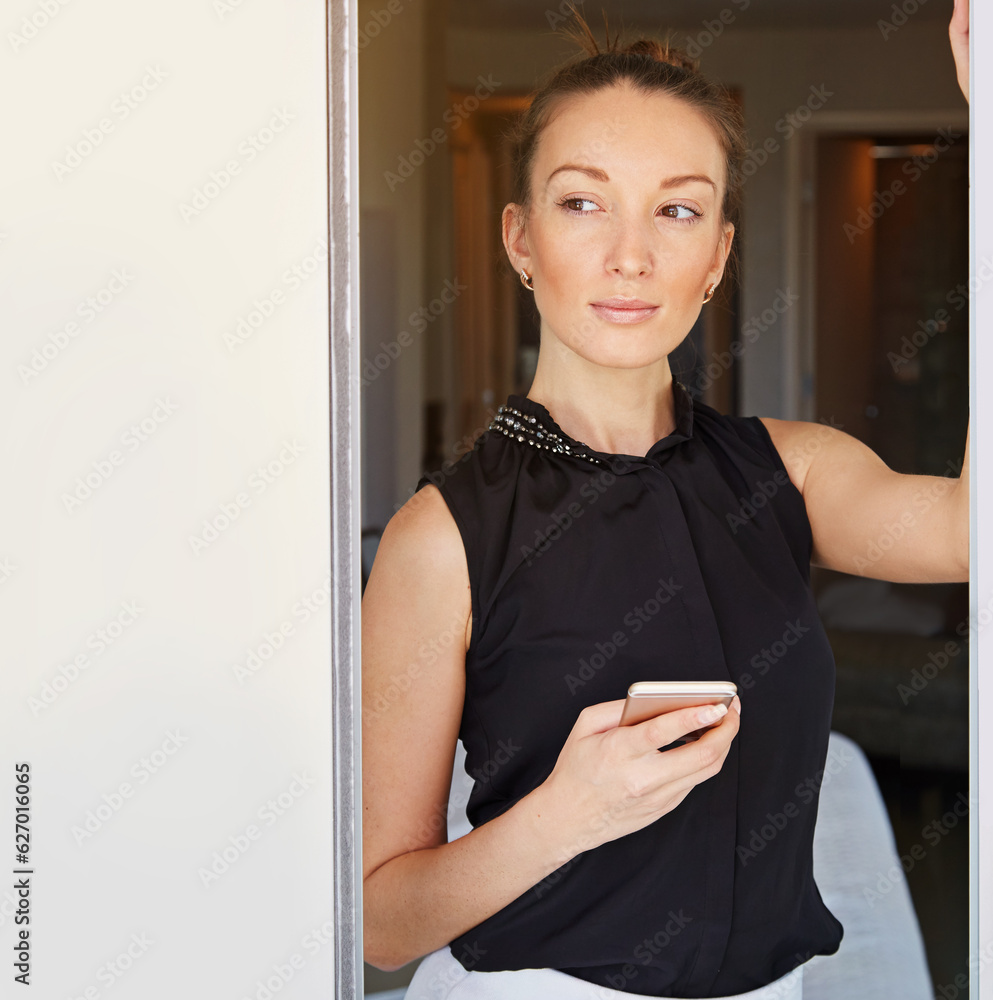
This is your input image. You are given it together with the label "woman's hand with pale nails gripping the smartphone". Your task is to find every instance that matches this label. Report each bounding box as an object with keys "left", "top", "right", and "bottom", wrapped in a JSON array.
[{"left": 532, "top": 696, "right": 741, "bottom": 864}]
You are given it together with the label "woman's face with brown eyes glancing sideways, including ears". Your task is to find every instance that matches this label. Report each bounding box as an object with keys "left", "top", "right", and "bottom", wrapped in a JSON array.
[{"left": 504, "top": 84, "right": 734, "bottom": 368}]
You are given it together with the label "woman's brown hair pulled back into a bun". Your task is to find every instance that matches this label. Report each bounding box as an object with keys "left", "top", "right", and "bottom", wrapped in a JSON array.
[{"left": 510, "top": 7, "right": 747, "bottom": 284}]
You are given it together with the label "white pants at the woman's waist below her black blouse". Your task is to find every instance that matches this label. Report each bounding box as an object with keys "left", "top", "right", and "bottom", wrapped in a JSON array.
[{"left": 404, "top": 945, "right": 803, "bottom": 1000}]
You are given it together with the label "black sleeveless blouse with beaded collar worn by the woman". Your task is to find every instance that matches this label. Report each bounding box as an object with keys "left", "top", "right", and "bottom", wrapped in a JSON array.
[{"left": 417, "top": 382, "right": 842, "bottom": 997}]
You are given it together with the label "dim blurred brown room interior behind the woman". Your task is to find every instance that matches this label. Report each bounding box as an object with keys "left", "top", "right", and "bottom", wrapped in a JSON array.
[{"left": 359, "top": 0, "right": 974, "bottom": 997}]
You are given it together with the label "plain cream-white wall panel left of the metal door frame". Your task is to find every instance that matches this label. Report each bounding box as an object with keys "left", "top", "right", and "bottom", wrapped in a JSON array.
[{"left": 0, "top": 0, "right": 333, "bottom": 1000}]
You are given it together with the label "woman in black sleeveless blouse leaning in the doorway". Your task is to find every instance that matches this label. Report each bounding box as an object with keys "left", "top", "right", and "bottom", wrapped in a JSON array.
[{"left": 362, "top": 0, "right": 969, "bottom": 1000}]
